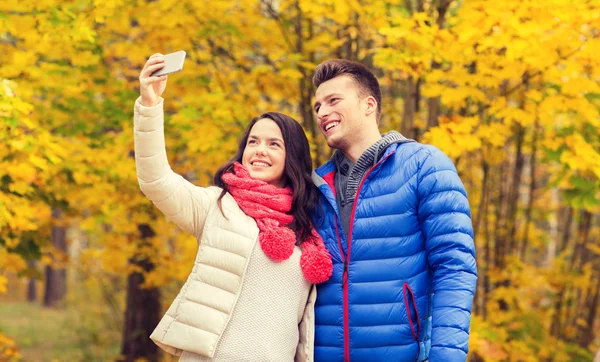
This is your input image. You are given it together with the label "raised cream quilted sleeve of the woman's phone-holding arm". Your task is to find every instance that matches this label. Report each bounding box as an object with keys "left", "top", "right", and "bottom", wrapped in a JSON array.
[{"left": 133, "top": 98, "right": 220, "bottom": 237}]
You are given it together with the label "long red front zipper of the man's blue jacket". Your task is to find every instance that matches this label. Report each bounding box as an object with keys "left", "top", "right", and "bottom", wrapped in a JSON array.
[{"left": 335, "top": 151, "right": 396, "bottom": 362}]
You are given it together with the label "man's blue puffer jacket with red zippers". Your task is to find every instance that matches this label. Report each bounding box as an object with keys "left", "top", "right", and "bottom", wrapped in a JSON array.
[{"left": 313, "top": 142, "right": 477, "bottom": 362}]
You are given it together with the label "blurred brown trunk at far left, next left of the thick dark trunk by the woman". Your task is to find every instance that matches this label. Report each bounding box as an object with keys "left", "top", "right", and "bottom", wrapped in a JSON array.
[{"left": 44, "top": 208, "right": 67, "bottom": 307}]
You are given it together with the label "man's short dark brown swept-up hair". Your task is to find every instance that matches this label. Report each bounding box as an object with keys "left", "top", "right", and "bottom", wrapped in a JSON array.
[{"left": 313, "top": 59, "right": 381, "bottom": 122}]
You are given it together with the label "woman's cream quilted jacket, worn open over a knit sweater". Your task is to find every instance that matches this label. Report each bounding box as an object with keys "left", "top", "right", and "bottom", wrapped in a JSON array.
[{"left": 134, "top": 99, "right": 316, "bottom": 361}]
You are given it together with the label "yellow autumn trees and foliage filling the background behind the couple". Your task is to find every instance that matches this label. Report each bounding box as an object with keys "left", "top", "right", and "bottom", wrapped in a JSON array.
[{"left": 0, "top": 0, "right": 600, "bottom": 362}]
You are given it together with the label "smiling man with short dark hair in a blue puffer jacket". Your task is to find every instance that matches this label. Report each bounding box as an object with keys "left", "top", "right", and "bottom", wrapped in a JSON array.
[{"left": 313, "top": 60, "right": 477, "bottom": 362}]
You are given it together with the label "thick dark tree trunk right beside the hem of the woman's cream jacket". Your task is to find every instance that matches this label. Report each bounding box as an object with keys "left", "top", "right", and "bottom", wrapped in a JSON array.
[{"left": 121, "top": 224, "right": 161, "bottom": 362}]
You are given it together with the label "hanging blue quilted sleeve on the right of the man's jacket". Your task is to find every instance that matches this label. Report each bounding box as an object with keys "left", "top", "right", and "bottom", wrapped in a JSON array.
[{"left": 417, "top": 146, "right": 477, "bottom": 362}]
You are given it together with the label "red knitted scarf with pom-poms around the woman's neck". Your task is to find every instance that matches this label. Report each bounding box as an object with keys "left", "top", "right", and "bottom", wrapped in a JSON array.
[{"left": 221, "top": 162, "right": 333, "bottom": 284}]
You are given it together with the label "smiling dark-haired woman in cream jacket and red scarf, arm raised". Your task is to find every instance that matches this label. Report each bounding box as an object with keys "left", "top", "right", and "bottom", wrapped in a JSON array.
[{"left": 134, "top": 54, "right": 332, "bottom": 362}]
